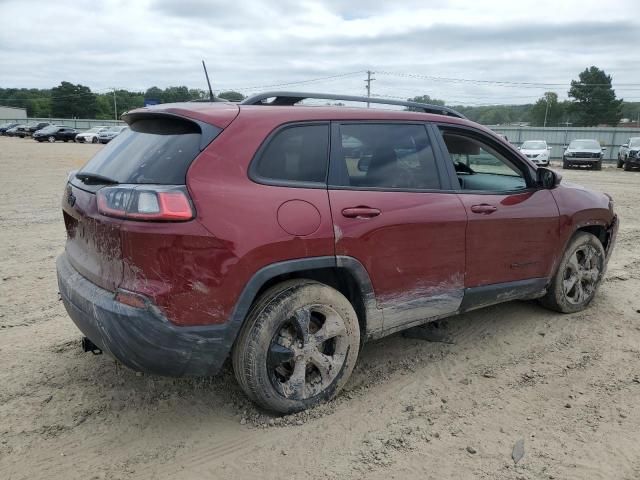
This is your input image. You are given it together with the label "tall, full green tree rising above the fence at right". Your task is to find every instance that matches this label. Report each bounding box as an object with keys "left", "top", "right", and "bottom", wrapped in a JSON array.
[{"left": 569, "top": 66, "right": 622, "bottom": 127}]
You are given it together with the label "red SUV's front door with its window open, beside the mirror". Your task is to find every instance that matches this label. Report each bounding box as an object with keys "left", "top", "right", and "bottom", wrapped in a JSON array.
[{"left": 439, "top": 125, "right": 559, "bottom": 290}]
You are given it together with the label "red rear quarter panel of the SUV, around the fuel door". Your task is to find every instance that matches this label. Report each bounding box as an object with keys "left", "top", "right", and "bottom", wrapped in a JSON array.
[{"left": 152, "top": 116, "right": 335, "bottom": 325}]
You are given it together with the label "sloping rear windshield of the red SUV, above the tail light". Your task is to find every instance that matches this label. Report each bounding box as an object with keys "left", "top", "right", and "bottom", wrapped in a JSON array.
[{"left": 82, "top": 117, "right": 220, "bottom": 185}]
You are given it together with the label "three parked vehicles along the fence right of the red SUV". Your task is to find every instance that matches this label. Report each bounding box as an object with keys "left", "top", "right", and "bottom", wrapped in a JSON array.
[{"left": 519, "top": 137, "right": 640, "bottom": 171}]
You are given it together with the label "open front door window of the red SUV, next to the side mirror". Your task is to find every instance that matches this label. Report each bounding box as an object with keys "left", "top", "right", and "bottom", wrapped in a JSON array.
[{"left": 441, "top": 128, "right": 527, "bottom": 192}]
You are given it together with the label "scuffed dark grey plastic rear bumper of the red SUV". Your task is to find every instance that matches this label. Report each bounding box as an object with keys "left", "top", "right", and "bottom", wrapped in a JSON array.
[{"left": 56, "top": 253, "right": 232, "bottom": 376}]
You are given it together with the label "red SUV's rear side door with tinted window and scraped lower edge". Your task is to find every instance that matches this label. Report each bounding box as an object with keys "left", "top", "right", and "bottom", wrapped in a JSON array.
[{"left": 329, "top": 122, "right": 467, "bottom": 332}]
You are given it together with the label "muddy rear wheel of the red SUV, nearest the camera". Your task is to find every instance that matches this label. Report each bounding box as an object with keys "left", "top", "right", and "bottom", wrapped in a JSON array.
[{"left": 232, "top": 280, "right": 360, "bottom": 414}]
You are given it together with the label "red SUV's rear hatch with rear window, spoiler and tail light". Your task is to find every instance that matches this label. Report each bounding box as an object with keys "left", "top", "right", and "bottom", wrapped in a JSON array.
[{"left": 62, "top": 111, "right": 221, "bottom": 291}]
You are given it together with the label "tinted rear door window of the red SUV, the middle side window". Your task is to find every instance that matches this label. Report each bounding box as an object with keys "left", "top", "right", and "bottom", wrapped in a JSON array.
[{"left": 332, "top": 123, "right": 440, "bottom": 190}]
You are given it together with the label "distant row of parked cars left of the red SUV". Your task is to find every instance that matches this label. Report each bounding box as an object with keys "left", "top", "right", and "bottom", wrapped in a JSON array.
[{"left": 0, "top": 122, "right": 129, "bottom": 143}]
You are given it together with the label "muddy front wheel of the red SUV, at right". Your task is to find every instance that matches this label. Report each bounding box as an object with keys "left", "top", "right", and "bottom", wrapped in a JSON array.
[{"left": 540, "top": 232, "right": 605, "bottom": 313}]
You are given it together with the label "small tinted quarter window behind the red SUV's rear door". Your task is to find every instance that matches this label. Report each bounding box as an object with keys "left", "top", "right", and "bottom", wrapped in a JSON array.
[{"left": 251, "top": 125, "right": 329, "bottom": 183}]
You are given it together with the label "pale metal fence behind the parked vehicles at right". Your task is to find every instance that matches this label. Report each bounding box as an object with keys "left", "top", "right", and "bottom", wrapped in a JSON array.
[{"left": 489, "top": 126, "right": 640, "bottom": 160}]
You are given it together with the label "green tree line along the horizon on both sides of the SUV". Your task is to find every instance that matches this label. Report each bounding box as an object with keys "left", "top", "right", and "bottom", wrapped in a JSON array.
[{"left": 0, "top": 66, "right": 640, "bottom": 127}]
